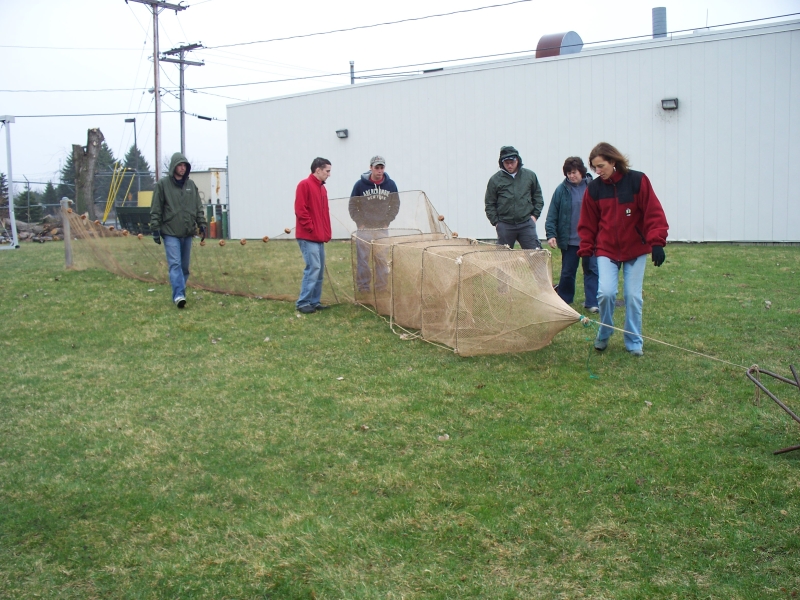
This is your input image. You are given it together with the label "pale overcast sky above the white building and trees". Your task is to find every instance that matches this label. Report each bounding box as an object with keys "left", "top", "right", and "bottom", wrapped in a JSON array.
[{"left": 0, "top": 0, "right": 800, "bottom": 190}]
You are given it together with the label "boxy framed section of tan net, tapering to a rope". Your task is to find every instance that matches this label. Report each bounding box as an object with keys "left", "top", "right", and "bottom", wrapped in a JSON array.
[{"left": 352, "top": 232, "right": 580, "bottom": 356}]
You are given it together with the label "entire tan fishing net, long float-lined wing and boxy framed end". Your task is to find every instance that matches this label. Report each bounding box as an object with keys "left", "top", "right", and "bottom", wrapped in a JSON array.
[{"left": 62, "top": 192, "right": 580, "bottom": 356}]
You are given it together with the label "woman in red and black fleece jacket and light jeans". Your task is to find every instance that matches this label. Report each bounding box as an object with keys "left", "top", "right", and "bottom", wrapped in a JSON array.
[{"left": 578, "top": 142, "right": 669, "bottom": 356}]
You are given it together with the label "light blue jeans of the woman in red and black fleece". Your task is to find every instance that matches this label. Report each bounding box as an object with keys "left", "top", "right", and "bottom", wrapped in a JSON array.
[{"left": 597, "top": 254, "right": 647, "bottom": 351}]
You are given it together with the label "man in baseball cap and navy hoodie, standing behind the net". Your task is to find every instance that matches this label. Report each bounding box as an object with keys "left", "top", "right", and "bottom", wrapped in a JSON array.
[{"left": 348, "top": 156, "right": 400, "bottom": 293}]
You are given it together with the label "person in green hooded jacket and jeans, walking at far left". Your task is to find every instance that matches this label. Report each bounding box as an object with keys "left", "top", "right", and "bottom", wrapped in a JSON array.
[{"left": 150, "top": 152, "right": 206, "bottom": 308}]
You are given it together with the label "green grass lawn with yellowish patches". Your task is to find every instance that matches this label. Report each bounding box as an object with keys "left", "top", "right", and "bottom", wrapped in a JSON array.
[{"left": 0, "top": 243, "right": 800, "bottom": 599}]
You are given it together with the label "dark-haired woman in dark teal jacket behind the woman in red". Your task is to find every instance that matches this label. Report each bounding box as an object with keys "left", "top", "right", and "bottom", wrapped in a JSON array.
[{"left": 544, "top": 156, "right": 599, "bottom": 313}]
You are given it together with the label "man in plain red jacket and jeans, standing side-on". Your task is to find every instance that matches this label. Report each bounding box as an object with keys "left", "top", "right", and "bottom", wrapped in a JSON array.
[{"left": 294, "top": 157, "right": 331, "bottom": 314}]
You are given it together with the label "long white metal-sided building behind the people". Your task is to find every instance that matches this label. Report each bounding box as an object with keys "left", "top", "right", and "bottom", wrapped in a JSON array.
[{"left": 228, "top": 20, "right": 800, "bottom": 242}]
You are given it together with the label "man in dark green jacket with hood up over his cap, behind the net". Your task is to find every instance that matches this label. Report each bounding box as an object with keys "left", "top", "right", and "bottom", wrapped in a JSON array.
[{"left": 485, "top": 146, "right": 544, "bottom": 249}]
